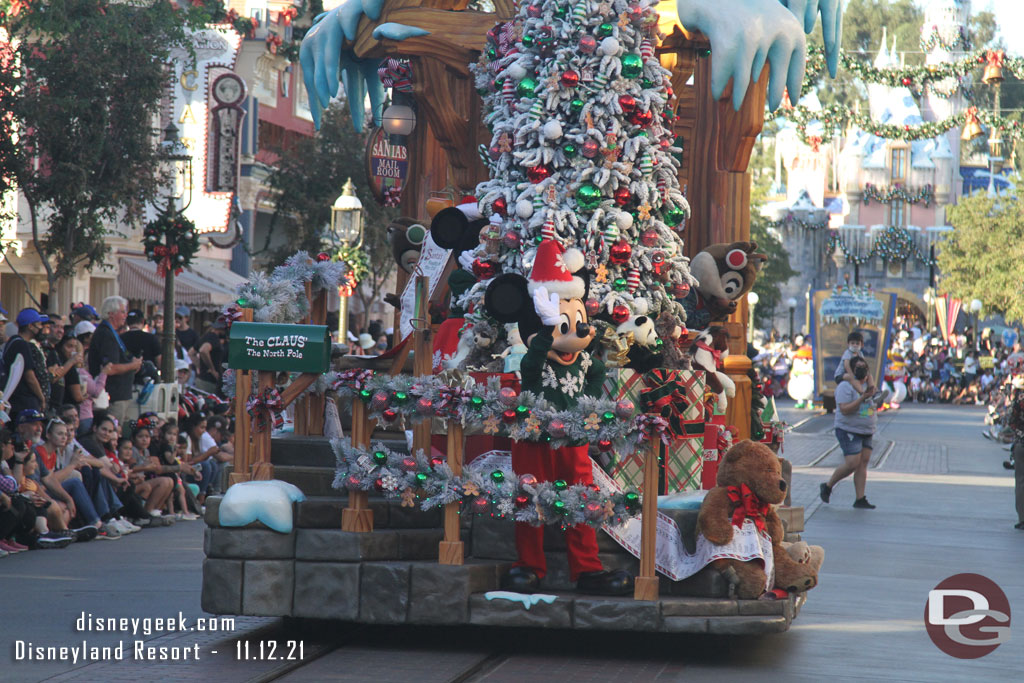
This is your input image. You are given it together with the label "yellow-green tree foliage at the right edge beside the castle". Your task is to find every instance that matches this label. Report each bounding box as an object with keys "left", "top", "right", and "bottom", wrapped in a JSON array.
[{"left": 938, "top": 183, "right": 1024, "bottom": 322}]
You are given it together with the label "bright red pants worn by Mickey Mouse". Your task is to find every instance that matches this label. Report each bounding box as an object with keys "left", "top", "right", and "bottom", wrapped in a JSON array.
[{"left": 512, "top": 441, "right": 604, "bottom": 581}]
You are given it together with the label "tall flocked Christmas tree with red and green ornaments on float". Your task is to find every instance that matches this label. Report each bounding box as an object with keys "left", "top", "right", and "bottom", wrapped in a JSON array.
[{"left": 467, "top": 0, "right": 693, "bottom": 331}]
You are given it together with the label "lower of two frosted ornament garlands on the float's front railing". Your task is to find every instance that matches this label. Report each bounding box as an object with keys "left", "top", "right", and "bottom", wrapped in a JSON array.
[{"left": 331, "top": 438, "right": 641, "bottom": 529}]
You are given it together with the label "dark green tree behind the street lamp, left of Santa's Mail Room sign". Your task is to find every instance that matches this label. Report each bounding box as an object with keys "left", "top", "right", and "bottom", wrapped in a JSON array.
[{"left": 260, "top": 103, "right": 398, "bottom": 323}]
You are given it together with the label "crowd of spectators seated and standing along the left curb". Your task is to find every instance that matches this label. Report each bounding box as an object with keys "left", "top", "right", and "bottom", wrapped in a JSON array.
[{"left": 0, "top": 297, "right": 234, "bottom": 557}]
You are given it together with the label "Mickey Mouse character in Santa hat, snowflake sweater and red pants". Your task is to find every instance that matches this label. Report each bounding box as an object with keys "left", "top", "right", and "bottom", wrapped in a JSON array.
[{"left": 484, "top": 240, "right": 633, "bottom": 595}]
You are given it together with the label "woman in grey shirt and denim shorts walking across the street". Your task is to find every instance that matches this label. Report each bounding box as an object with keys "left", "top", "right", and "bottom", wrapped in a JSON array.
[{"left": 821, "top": 358, "right": 878, "bottom": 510}]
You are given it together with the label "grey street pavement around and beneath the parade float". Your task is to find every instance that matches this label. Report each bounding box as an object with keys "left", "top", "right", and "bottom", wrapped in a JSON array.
[{"left": 0, "top": 403, "right": 1024, "bottom": 683}]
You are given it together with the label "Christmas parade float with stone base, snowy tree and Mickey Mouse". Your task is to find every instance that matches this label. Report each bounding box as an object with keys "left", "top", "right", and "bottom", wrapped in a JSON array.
[{"left": 203, "top": 0, "right": 839, "bottom": 634}]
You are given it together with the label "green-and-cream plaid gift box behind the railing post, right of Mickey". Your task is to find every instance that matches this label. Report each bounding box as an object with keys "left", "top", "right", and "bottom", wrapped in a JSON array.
[{"left": 604, "top": 368, "right": 705, "bottom": 495}]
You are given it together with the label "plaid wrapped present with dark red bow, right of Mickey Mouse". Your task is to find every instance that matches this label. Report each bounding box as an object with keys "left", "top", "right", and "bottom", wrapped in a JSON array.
[{"left": 604, "top": 368, "right": 705, "bottom": 495}]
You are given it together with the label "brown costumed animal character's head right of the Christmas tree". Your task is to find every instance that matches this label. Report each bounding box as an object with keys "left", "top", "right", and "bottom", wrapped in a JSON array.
[{"left": 680, "top": 242, "right": 768, "bottom": 330}]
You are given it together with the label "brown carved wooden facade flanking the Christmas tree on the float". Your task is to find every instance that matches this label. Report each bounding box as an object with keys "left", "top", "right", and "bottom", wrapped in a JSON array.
[{"left": 354, "top": 7, "right": 768, "bottom": 438}]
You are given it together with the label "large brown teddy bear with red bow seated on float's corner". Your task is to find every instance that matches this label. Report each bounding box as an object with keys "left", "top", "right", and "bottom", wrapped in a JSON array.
[{"left": 697, "top": 439, "right": 823, "bottom": 600}]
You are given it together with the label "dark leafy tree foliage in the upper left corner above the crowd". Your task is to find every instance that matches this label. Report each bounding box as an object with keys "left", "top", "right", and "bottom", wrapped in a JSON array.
[{"left": 0, "top": 0, "right": 209, "bottom": 299}]
